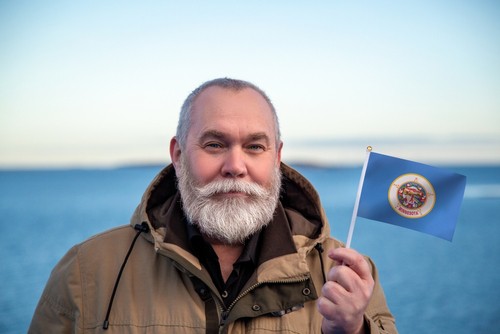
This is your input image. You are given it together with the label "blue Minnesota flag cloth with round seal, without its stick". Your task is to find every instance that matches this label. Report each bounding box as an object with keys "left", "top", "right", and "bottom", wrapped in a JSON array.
[{"left": 357, "top": 152, "right": 466, "bottom": 241}]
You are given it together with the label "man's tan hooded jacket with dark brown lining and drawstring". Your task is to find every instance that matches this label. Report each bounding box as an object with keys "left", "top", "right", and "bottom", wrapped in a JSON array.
[{"left": 29, "top": 164, "right": 397, "bottom": 334}]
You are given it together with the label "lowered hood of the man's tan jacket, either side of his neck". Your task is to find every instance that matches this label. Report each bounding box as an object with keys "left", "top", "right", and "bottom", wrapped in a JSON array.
[{"left": 131, "top": 163, "right": 330, "bottom": 254}]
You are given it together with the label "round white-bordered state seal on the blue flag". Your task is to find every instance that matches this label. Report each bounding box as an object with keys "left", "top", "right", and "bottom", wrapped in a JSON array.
[{"left": 388, "top": 173, "right": 436, "bottom": 218}]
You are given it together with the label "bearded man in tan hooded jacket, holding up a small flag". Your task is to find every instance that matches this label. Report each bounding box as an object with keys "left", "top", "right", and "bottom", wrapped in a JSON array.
[{"left": 30, "top": 78, "right": 397, "bottom": 333}]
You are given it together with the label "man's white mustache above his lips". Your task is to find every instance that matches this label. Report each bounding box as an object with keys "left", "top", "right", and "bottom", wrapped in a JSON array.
[{"left": 197, "top": 179, "right": 268, "bottom": 197}]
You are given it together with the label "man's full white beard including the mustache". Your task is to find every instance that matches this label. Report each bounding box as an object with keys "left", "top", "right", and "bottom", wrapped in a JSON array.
[{"left": 176, "top": 156, "right": 281, "bottom": 245}]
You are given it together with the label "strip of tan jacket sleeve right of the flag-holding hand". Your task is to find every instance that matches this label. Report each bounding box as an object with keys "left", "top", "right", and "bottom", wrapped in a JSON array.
[{"left": 365, "top": 258, "right": 398, "bottom": 334}]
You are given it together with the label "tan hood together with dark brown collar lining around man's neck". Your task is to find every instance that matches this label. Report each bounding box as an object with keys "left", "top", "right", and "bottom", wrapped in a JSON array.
[{"left": 131, "top": 163, "right": 329, "bottom": 266}]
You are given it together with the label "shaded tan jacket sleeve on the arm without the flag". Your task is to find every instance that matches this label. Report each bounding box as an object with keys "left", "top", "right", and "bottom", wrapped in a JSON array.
[{"left": 28, "top": 246, "right": 82, "bottom": 334}]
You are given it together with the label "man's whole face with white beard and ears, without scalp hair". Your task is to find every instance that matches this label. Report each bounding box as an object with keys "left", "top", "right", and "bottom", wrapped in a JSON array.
[{"left": 171, "top": 85, "right": 281, "bottom": 244}]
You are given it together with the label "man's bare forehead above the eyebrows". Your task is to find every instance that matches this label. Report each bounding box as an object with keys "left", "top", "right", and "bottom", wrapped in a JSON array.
[{"left": 189, "top": 87, "right": 276, "bottom": 140}]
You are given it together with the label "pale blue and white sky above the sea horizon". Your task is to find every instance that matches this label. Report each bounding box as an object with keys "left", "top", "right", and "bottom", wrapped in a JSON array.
[{"left": 0, "top": 0, "right": 500, "bottom": 168}]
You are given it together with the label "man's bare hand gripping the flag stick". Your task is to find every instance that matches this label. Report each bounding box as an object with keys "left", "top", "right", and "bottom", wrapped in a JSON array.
[{"left": 318, "top": 248, "right": 374, "bottom": 334}]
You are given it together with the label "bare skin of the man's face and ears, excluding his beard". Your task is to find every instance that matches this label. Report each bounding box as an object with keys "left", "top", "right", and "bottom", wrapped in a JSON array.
[{"left": 170, "top": 87, "right": 282, "bottom": 190}]
